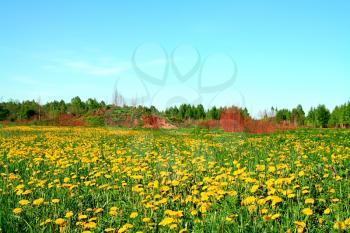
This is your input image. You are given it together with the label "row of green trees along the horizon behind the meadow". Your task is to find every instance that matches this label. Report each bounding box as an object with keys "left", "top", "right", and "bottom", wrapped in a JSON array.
[{"left": 0, "top": 96, "right": 350, "bottom": 128}]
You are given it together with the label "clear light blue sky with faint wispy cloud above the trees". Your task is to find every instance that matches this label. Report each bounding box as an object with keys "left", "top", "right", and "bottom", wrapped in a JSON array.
[{"left": 0, "top": 0, "right": 350, "bottom": 115}]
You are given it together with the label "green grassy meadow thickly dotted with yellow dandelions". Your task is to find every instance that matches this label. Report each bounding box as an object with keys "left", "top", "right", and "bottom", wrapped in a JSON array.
[{"left": 0, "top": 126, "right": 350, "bottom": 233}]
